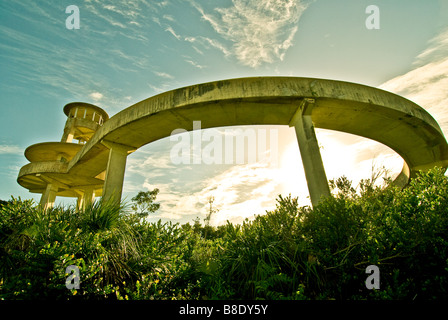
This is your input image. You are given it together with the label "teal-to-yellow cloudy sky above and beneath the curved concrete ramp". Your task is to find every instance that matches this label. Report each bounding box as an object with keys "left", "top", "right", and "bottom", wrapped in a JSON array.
[{"left": 0, "top": 0, "right": 448, "bottom": 225}]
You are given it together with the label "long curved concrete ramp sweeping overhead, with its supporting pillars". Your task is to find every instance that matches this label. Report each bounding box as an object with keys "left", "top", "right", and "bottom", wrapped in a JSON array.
[{"left": 18, "top": 77, "right": 448, "bottom": 209}]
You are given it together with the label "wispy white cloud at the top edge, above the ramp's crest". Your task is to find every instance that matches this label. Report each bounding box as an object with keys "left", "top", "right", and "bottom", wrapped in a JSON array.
[{"left": 193, "top": 0, "right": 309, "bottom": 68}]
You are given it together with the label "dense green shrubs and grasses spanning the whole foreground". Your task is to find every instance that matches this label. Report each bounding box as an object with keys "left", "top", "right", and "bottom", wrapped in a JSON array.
[{"left": 0, "top": 169, "right": 448, "bottom": 300}]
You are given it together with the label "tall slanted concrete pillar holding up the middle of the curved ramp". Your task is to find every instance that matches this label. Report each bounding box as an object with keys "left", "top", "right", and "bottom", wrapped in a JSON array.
[{"left": 290, "top": 99, "right": 331, "bottom": 206}]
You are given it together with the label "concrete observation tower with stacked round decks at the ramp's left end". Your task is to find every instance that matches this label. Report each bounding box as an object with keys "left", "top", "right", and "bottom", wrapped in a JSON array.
[{"left": 18, "top": 102, "right": 109, "bottom": 209}]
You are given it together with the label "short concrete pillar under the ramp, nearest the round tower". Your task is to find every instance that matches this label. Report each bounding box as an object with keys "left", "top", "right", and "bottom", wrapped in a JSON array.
[{"left": 102, "top": 141, "right": 134, "bottom": 204}]
